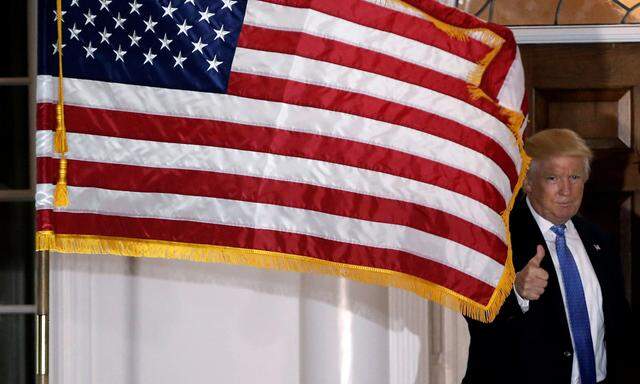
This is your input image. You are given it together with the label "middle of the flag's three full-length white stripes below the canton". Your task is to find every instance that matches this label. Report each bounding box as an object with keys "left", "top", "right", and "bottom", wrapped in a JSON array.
[{"left": 36, "top": 131, "right": 506, "bottom": 243}]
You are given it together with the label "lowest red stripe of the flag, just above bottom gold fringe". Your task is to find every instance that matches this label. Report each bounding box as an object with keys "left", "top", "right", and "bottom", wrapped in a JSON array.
[{"left": 40, "top": 211, "right": 494, "bottom": 305}]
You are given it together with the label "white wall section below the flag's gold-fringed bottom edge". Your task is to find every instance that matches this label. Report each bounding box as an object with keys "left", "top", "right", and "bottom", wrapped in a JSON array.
[{"left": 50, "top": 254, "right": 468, "bottom": 384}]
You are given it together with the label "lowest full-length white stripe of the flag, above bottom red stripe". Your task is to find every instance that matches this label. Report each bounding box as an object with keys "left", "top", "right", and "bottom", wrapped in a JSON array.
[{"left": 36, "top": 184, "right": 504, "bottom": 287}]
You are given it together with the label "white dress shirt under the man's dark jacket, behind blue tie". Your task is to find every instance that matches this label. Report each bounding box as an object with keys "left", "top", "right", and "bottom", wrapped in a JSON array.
[{"left": 514, "top": 198, "right": 607, "bottom": 384}]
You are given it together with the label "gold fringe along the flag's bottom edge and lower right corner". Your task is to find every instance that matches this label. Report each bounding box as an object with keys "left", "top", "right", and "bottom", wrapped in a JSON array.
[{"left": 36, "top": 231, "right": 513, "bottom": 322}]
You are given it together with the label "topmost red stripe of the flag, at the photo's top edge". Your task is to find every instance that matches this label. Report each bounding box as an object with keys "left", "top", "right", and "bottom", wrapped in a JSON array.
[{"left": 256, "top": 0, "right": 491, "bottom": 63}]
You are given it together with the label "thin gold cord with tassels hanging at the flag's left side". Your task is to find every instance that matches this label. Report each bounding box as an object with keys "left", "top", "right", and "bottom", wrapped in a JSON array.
[{"left": 53, "top": 0, "right": 69, "bottom": 207}]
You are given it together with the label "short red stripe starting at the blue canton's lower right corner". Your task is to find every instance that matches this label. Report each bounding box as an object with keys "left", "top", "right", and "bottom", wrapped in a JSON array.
[{"left": 228, "top": 72, "right": 518, "bottom": 188}]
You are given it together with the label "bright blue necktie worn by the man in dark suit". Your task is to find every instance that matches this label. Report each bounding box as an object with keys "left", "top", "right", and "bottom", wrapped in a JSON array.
[{"left": 551, "top": 224, "right": 596, "bottom": 384}]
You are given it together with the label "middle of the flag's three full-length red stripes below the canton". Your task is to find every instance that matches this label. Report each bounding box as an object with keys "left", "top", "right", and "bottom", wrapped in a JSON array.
[{"left": 38, "top": 158, "right": 507, "bottom": 264}]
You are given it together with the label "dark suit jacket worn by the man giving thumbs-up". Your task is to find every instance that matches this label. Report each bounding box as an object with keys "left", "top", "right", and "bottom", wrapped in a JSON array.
[{"left": 463, "top": 193, "right": 631, "bottom": 384}]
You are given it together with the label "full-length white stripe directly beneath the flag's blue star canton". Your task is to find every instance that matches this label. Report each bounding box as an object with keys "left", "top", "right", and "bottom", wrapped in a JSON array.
[{"left": 37, "top": 76, "right": 519, "bottom": 203}]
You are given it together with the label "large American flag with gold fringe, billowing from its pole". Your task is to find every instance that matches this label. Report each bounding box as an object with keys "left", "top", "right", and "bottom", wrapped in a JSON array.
[{"left": 36, "top": 0, "right": 525, "bottom": 320}]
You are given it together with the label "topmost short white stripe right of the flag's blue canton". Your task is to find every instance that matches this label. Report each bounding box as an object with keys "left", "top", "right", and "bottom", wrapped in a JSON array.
[{"left": 245, "top": 1, "right": 477, "bottom": 80}]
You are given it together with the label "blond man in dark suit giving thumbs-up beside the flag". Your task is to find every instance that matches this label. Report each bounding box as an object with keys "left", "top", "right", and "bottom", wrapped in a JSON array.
[{"left": 463, "top": 129, "right": 630, "bottom": 384}]
